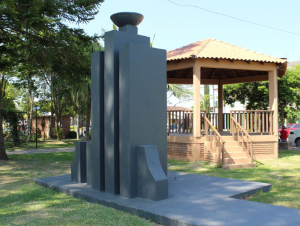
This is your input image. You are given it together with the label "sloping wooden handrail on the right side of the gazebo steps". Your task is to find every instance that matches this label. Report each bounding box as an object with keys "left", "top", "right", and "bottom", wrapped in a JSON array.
[{"left": 230, "top": 117, "right": 253, "bottom": 163}]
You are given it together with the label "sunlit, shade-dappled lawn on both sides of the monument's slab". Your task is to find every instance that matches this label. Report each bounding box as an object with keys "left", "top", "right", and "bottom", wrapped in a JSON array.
[{"left": 0, "top": 151, "right": 300, "bottom": 225}]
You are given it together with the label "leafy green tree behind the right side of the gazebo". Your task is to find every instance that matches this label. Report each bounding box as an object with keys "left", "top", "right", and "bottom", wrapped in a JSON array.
[{"left": 223, "top": 66, "right": 300, "bottom": 126}]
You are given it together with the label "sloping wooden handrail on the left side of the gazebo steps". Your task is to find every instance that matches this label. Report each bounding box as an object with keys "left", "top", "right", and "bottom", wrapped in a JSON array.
[{"left": 204, "top": 117, "right": 225, "bottom": 165}]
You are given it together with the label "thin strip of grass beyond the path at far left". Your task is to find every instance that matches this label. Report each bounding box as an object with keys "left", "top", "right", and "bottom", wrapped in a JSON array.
[{"left": 6, "top": 139, "right": 82, "bottom": 151}]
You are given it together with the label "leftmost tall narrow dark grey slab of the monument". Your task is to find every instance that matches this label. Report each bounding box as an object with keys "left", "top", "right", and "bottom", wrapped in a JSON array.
[{"left": 87, "top": 52, "right": 105, "bottom": 191}]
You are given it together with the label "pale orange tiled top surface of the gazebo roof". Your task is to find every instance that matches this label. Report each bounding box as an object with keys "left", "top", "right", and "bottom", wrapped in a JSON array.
[{"left": 167, "top": 39, "right": 286, "bottom": 63}]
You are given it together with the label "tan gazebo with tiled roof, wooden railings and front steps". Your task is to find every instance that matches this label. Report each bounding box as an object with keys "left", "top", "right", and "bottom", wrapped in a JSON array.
[{"left": 167, "top": 39, "right": 287, "bottom": 168}]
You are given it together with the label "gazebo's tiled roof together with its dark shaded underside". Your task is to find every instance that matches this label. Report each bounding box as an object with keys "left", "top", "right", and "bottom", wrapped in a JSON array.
[{"left": 167, "top": 39, "right": 287, "bottom": 79}]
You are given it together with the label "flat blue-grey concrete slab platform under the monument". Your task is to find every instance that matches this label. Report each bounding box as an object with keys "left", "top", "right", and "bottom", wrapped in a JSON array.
[{"left": 35, "top": 172, "right": 300, "bottom": 226}]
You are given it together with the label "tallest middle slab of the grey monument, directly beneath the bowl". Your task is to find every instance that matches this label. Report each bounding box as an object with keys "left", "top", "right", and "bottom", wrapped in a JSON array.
[{"left": 104, "top": 18, "right": 150, "bottom": 194}]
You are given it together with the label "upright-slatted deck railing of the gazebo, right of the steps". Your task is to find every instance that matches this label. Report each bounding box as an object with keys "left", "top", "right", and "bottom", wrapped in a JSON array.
[{"left": 230, "top": 110, "right": 274, "bottom": 135}]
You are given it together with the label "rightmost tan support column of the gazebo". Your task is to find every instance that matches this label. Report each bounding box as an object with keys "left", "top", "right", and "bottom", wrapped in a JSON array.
[{"left": 268, "top": 68, "right": 278, "bottom": 158}]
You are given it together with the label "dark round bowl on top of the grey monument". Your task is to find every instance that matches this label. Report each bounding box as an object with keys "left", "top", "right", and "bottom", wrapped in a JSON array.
[{"left": 110, "top": 12, "right": 144, "bottom": 27}]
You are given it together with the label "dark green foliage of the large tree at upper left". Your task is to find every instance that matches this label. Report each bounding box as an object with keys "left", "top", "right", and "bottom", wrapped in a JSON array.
[{"left": 0, "top": 0, "right": 103, "bottom": 160}]
